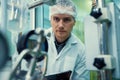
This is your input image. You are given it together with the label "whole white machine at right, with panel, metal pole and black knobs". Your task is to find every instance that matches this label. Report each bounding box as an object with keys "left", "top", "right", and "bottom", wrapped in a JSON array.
[{"left": 85, "top": 0, "right": 120, "bottom": 80}]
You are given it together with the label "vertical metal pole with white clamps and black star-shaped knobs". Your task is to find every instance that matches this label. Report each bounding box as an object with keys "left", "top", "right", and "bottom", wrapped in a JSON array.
[{"left": 90, "top": 0, "right": 112, "bottom": 80}]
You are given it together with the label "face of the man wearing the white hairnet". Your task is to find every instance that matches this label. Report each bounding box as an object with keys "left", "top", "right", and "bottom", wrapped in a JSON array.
[{"left": 51, "top": 14, "right": 75, "bottom": 42}]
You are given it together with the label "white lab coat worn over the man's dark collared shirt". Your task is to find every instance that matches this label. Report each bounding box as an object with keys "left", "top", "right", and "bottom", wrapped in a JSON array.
[{"left": 46, "top": 28, "right": 89, "bottom": 80}]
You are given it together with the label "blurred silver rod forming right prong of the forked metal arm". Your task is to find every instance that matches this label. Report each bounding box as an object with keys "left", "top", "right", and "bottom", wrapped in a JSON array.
[{"left": 26, "top": 30, "right": 45, "bottom": 80}]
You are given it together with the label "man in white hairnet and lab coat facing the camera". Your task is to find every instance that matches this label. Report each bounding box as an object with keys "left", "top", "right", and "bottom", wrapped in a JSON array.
[{"left": 46, "top": 0, "right": 89, "bottom": 80}]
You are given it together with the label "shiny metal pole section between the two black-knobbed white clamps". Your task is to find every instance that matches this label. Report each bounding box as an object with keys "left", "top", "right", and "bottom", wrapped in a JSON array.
[{"left": 97, "top": 22, "right": 108, "bottom": 54}]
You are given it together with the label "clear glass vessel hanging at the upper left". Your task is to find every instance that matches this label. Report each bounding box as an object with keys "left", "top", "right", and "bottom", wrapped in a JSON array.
[{"left": 7, "top": 0, "right": 31, "bottom": 33}]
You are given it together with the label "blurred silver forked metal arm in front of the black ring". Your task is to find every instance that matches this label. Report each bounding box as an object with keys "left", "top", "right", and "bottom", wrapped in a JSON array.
[{"left": 8, "top": 30, "right": 47, "bottom": 80}]
